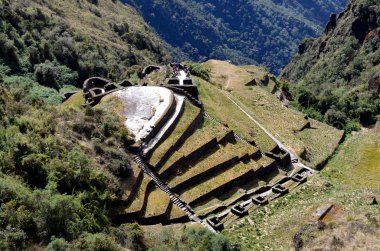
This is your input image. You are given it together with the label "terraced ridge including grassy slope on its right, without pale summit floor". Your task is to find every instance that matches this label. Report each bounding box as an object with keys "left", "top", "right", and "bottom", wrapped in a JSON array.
[{"left": 68, "top": 61, "right": 342, "bottom": 230}]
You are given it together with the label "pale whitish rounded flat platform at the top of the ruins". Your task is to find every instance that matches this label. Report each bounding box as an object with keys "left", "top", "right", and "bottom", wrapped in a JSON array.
[{"left": 111, "top": 86, "right": 175, "bottom": 142}]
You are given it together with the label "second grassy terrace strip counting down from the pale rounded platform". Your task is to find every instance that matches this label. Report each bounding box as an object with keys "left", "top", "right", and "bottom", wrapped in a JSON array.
[{"left": 159, "top": 118, "right": 230, "bottom": 174}]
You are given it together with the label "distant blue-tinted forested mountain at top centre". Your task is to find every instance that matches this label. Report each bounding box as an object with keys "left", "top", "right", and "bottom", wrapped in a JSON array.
[{"left": 123, "top": 0, "right": 347, "bottom": 73}]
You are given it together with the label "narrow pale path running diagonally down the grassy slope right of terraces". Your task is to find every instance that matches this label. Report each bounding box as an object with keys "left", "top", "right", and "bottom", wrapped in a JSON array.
[{"left": 221, "top": 90, "right": 317, "bottom": 173}]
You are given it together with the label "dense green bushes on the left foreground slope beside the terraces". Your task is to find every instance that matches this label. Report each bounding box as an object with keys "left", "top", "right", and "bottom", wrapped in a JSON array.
[{"left": 0, "top": 85, "right": 138, "bottom": 249}]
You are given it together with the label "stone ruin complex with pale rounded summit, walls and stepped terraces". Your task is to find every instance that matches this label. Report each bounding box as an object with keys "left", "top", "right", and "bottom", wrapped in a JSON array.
[{"left": 63, "top": 64, "right": 313, "bottom": 231}]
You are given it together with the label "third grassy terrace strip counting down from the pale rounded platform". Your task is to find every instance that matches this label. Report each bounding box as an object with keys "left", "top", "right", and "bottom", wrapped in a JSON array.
[{"left": 169, "top": 142, "right": 257, "bottom": 188}]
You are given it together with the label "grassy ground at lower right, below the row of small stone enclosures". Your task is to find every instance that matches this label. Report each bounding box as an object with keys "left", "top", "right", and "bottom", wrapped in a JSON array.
[{"left": 224, "top": 130, "right": 380, "bottom": 250}]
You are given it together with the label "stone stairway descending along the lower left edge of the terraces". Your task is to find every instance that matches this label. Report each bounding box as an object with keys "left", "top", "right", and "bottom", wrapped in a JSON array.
[{"left": 132, "top": 155, "right": 216, "bottom": 233}]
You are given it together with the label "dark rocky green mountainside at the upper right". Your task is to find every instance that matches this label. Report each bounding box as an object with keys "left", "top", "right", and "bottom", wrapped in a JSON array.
[{"left": 280, "top": 0, "right": 380, "bottom": 130}]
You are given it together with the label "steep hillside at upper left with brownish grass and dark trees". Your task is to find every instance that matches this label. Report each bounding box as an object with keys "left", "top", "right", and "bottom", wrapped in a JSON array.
[{"left": 0, "top": 0, "right": 170, "bottom": 101}]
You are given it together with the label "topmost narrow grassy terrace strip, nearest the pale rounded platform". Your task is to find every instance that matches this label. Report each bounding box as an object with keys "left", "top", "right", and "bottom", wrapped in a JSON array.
[{"left": 148, "top": 101, "right": 201, "bottom": 166}]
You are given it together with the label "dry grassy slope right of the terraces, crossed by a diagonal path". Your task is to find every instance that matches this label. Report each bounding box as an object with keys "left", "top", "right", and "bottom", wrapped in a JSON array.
[{"left": 199, "top": 61, "right": 343, "bottom": 167}]
